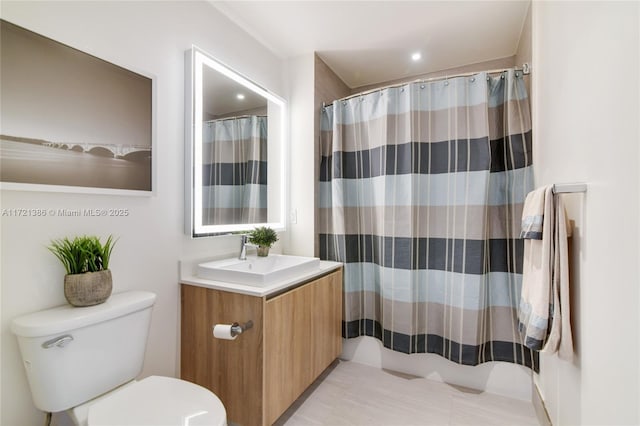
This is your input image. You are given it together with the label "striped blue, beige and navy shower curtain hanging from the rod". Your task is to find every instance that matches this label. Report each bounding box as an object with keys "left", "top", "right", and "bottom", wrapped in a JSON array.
[{"left": 319, "top": 70, "right": 538, "bottom": 371}]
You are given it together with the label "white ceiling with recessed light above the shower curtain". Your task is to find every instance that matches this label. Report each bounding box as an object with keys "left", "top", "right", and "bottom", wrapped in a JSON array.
[{"left": 211, "top": 0, "right": 530, "bottom": 88}]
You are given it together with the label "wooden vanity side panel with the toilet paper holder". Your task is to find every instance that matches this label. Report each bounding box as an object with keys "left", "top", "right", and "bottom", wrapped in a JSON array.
[{"left": 180, "top": 285, "right": 264, "bottom": 426}]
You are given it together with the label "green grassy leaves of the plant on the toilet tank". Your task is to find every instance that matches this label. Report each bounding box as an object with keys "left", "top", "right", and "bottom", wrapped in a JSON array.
[{"left": 47, "top": 235, "right": 116, "bottom": 274}]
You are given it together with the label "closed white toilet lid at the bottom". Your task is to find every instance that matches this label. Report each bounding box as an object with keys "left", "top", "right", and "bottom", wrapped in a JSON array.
[{"left": 88, "top": 376, "right": 227, "bottom": 426}]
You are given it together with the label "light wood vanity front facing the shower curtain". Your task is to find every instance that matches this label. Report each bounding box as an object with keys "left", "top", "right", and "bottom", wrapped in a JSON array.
[{"left": 264, "top": 270, "right": 342, "bottom": 424}]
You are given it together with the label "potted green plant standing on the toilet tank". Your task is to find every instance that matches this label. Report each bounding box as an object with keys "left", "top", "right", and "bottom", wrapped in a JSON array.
[{"left": 48, "top": 235, "right": 115, "bottom": 306}]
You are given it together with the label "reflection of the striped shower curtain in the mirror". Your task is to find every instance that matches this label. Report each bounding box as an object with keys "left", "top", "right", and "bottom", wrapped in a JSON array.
[{"left": 202, "top": 115, "right": 267, "bottom": 225}]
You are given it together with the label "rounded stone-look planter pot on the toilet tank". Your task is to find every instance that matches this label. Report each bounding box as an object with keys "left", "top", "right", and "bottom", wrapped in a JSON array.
[{"left": 64, "top": 269, "right": 113, "bottom": 306}]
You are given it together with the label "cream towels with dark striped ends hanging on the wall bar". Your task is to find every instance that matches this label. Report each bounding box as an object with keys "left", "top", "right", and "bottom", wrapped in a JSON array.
[{"left": 518, "top": 186, "right": 573, "bottom": 360}]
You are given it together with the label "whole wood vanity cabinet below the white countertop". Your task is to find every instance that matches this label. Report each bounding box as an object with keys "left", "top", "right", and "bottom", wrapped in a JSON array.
[{"left": 180, "top": 268, "right": 342, "bottom": 426}]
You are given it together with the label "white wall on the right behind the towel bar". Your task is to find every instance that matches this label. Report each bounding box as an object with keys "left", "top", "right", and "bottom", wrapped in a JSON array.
[{"left": 532, "top": 2, "right": 640, "bottom": 425}]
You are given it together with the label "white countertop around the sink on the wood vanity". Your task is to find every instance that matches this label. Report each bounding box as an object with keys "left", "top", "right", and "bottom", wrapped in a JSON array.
[{"left": 179, "top": 259, "right": 342, "bottom": 297}]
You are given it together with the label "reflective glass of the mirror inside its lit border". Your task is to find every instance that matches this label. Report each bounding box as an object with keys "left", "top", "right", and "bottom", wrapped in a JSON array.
[{"left": 202, "top": 68, "right": 268, "bottom": 226}]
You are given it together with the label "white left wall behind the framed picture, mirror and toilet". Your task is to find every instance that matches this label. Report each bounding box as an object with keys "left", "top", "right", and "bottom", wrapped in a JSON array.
[{"left": 0, "top": 1, "right": 284, "bottom": 425}]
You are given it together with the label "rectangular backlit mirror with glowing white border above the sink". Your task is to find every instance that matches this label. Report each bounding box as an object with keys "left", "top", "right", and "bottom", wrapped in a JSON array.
[{"left": 185, "top": 47, "right": 286, "bottom": 237}]
